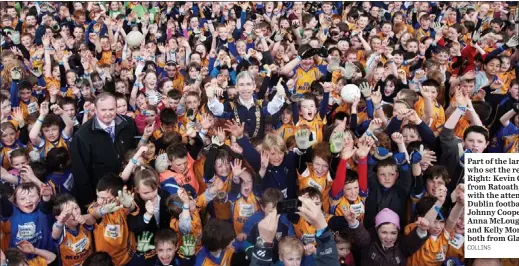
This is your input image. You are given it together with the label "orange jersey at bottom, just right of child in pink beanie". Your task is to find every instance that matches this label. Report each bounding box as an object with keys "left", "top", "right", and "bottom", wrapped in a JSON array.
[{"left": 405, "top": 224, "right": 449, "bottom": 266}]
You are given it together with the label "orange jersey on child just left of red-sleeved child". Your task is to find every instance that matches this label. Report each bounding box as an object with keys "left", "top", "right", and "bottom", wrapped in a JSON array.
[{"left": 297, "top": 163, "right": 333, "bottom": 213}]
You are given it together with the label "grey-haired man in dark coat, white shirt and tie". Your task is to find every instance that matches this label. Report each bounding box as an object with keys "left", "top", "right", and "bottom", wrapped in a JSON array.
[{"left": 71, "top": 93, "right": 138, "bottom": 208}]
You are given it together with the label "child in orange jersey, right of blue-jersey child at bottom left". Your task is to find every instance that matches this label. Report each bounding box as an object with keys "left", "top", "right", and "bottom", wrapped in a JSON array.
[{"left": 52, "top": 194, "right": 95, "bottom": 266}]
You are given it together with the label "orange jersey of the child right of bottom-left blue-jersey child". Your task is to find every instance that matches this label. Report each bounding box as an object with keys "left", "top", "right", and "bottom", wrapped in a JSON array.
[{"left": 59, "top": 225, "right": 94, "bottom": 266}]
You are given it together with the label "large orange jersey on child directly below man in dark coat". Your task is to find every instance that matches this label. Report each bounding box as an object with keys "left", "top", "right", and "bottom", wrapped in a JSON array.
[{"left": 88, "top": 203, "right": 139, "bottom": 265}]
